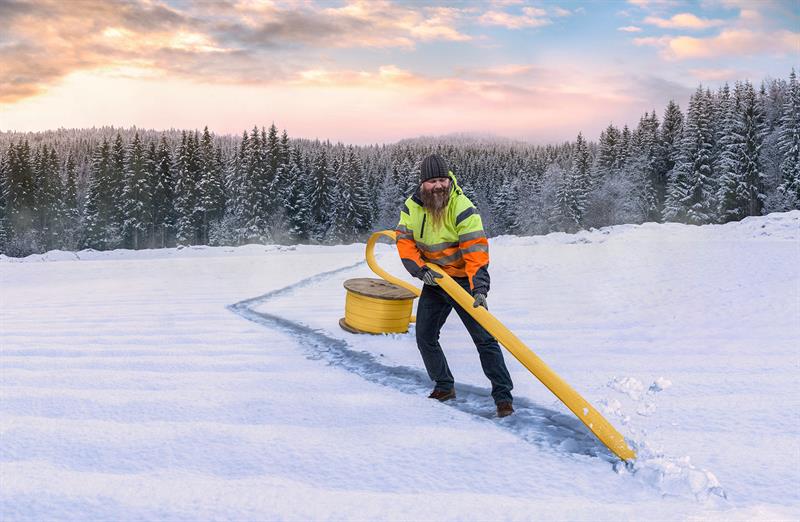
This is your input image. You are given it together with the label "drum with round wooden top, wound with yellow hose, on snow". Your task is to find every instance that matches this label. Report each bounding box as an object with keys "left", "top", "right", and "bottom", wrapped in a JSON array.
[{"left": 339, "top": 277, "right": 417, "bottom": 334}]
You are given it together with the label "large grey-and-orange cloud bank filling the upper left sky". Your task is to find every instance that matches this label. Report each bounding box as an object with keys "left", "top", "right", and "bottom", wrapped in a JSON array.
[{"left": 0, "top": 0, "right": 471, "bottom": 103}]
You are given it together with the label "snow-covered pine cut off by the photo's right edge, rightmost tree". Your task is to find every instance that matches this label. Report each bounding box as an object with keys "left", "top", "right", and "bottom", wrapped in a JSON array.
[{"left": 778, "top": 69, "right": 800, "bottom": 210}]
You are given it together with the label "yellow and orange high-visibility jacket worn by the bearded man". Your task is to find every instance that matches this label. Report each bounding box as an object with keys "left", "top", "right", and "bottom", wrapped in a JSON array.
[{"left": 396, "top": 172, "right": 489, "bottom": 294}]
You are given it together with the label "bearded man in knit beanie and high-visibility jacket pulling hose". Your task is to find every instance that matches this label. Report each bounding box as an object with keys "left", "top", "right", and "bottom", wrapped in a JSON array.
[{"left": 397, "top": 154, "right": 514, "bottom": 417}]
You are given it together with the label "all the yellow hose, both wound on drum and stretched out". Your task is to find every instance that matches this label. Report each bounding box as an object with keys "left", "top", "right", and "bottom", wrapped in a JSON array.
[{"left": 339, "top": 230, "right": 636, "bottom": 460}]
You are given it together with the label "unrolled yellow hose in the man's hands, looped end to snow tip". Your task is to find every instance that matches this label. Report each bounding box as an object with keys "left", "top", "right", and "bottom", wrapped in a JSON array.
[{"left": 366, "top": 230, "right": 636, "bottom": 460}]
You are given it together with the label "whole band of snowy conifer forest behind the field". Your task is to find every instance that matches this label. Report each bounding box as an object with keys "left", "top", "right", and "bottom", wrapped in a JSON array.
[{"left": 0, "top": 71, "right": 800, "bottom": 256}]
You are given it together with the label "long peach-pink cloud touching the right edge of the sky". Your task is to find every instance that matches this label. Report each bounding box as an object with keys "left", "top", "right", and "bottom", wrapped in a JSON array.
[{"left": 633, "top": 29, "right": 800, "bottom": 60}]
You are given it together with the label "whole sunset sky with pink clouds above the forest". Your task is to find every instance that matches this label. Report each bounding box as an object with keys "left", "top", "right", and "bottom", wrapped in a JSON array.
[{"left": 0, "top": 0, "right": 800, "bottom": 144}]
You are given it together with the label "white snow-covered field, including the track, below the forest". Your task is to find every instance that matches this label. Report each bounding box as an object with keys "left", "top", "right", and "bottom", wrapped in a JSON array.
[{"left": 0, "top": 211, "right": 800, "bottom": 520}]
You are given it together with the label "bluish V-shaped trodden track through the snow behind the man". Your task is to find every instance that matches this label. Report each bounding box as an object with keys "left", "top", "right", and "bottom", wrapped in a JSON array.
[{"left": 228, "top": 261, "right": 619, "bottom": 463}]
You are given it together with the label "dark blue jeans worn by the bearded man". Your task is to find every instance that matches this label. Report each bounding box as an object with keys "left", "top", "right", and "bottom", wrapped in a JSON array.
[{"left": 416, "top": 278, "right": 514, "bottom": 403}]
